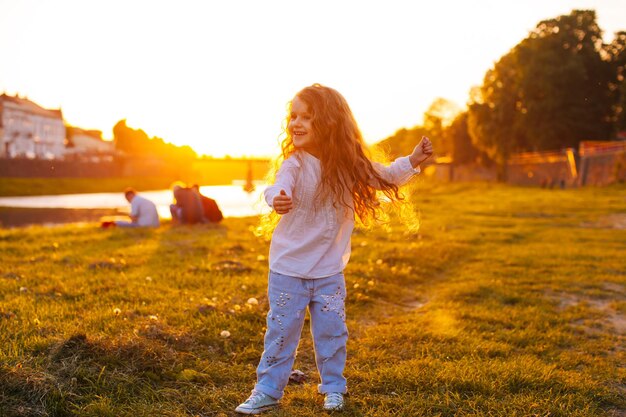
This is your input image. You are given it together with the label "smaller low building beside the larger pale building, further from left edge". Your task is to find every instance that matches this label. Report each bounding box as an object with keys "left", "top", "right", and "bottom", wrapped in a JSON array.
[{"left": 65, "top": 126, "right": 115, "bottom": 162}]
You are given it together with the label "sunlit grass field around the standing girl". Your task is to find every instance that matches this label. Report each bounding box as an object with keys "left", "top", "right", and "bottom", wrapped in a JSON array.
[{"left": 0, "top": 183, "right": 626, "bottom": 417}]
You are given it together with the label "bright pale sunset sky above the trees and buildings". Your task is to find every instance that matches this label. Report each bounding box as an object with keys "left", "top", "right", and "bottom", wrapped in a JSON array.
[{"left": 0, "top": 0, "right": 626, "bottom": 156}]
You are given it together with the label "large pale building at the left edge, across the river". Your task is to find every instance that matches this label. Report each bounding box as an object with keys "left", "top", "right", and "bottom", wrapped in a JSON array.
[{"left": 0, "top": 94, "right": 65, "bottom": 159}]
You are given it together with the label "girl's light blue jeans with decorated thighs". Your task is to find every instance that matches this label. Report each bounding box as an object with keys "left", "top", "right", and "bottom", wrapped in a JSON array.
[{"left": 254, "top": 272, "right": 348, "bottom": 399}]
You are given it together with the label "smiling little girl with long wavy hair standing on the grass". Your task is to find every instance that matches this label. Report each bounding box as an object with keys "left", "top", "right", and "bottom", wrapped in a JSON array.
[{"left": 235, "top": 84, "right": 433, "bottom": 414}]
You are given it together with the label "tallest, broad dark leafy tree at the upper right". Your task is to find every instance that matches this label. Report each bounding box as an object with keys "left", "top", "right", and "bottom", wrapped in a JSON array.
[{"left": 468, "top": 10, "right": 613, "bottom": 174}]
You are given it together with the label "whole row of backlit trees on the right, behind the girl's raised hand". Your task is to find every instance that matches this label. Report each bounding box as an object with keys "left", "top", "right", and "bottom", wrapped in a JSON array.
[{"left": 379, "top": 10, "right": 626, "bottom": 177}]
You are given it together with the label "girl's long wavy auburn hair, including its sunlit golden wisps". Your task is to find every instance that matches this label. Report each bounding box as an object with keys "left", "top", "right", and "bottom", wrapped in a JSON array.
[{"left": 254, "top": 84, "right": 421, "bottom": 240}]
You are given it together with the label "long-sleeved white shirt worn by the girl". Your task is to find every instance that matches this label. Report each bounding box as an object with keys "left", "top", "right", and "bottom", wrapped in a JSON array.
[{"left": 264, "top": 151, "right": 420, "bottom": 279}]
